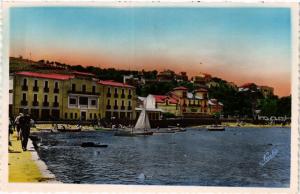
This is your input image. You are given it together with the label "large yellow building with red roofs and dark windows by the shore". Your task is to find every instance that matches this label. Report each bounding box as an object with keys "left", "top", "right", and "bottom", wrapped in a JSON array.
[{"left": 10, "top": 72, "right": 136, "bottom": 120}]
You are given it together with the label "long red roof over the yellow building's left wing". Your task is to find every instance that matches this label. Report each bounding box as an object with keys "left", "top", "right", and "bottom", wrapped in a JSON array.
[{"left": 16, "top": 71, "right": 74, "bottom": 80}]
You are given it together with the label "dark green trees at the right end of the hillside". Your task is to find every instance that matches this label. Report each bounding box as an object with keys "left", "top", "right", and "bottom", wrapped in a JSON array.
[{"left": 209, "top": 78, "right": 291, "bottom": 118}]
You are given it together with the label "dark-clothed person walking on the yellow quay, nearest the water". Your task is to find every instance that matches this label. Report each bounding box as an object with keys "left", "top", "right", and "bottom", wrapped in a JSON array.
[{"left": 19, "top": 110, "right": 31, "bottom": 151}]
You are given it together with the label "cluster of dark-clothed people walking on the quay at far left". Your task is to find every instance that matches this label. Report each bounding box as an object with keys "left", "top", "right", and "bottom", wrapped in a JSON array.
[{"left": 8, "top": 113, "right": 34, "bottom": 151}]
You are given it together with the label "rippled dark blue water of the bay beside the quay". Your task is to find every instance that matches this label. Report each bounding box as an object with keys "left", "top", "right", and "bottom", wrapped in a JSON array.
[{"left": 34, "top": 128, "right": 290, "bottom": 187}]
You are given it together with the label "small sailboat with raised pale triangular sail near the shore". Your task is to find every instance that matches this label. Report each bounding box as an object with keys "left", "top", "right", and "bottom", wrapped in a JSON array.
[{"left": 115, "top": 108, "right": 153, "bottom": 136}]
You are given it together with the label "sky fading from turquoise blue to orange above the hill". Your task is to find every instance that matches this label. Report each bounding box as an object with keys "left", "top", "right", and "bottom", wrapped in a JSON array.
[{"left": 10, "top": 7, "right": 292, "bottom": 96}]
